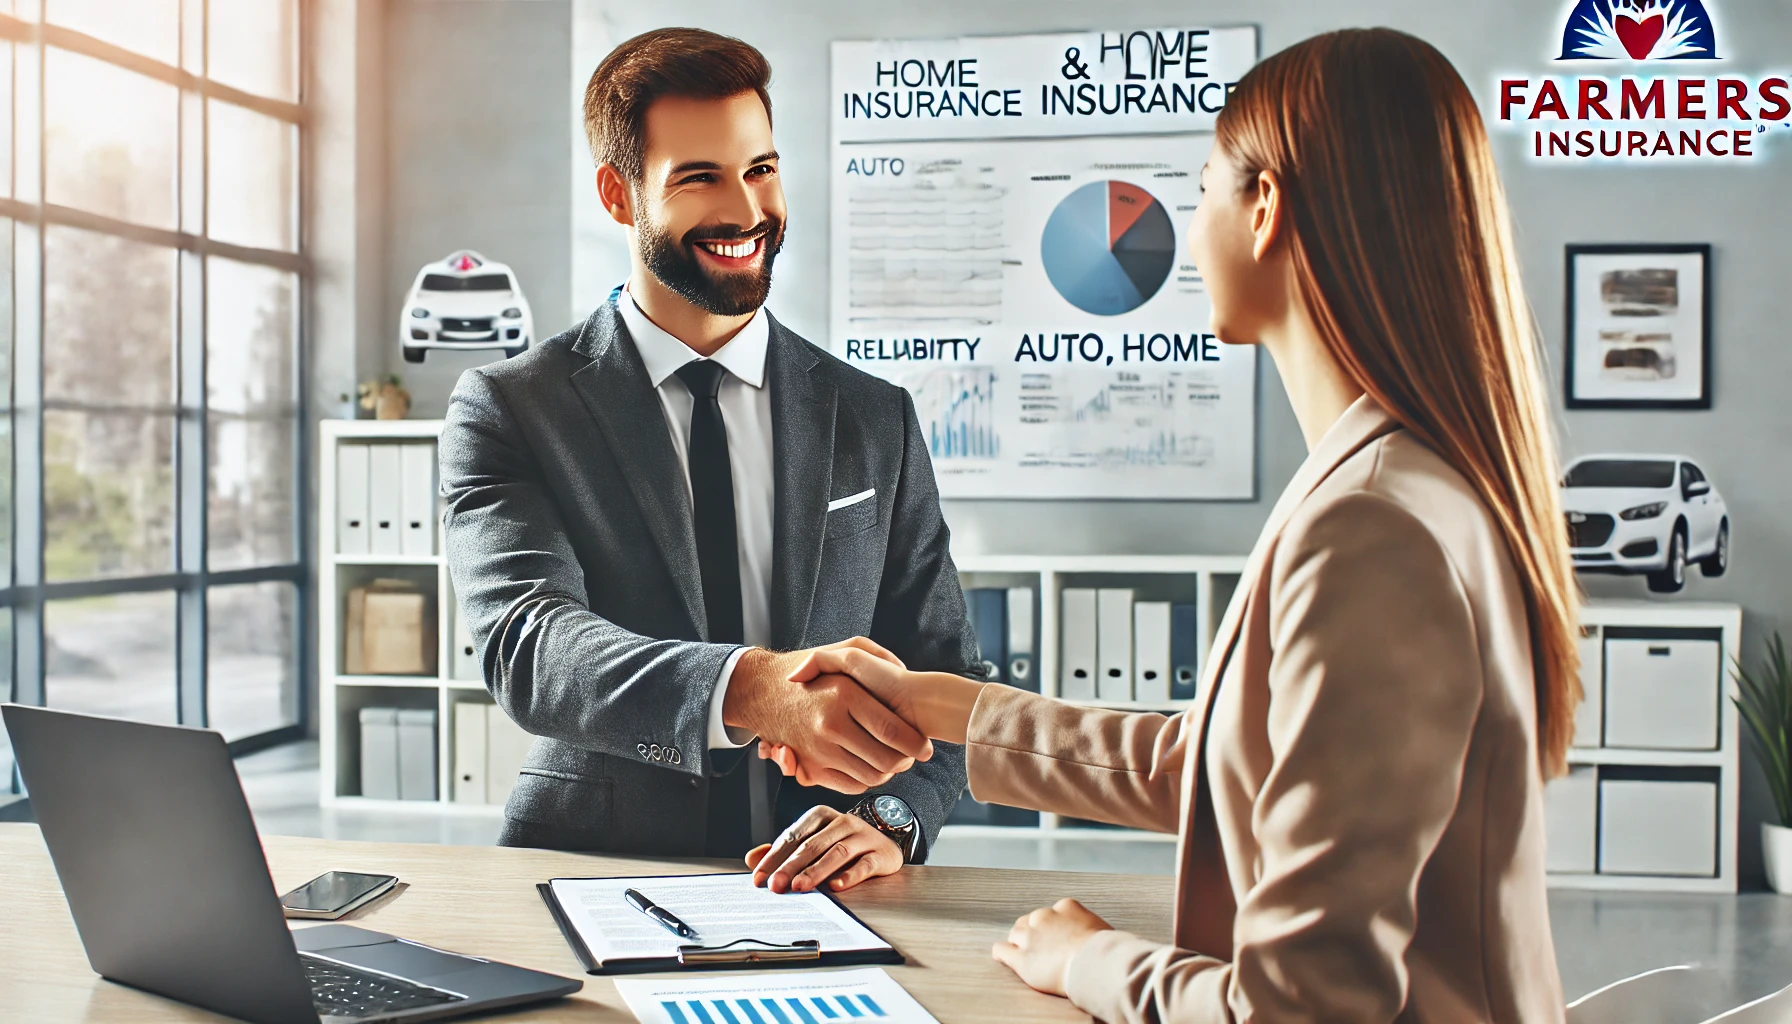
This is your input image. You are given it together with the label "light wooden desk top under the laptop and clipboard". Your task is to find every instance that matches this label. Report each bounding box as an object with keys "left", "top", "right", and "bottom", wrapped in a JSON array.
[{"left": 0, "top": 825, "right": 1172, "bottom": 1024}]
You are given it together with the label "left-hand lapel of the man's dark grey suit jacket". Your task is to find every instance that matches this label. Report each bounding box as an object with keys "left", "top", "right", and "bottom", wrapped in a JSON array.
[{"left": 572, "top": 303, "right": 710, "bottom": 637}]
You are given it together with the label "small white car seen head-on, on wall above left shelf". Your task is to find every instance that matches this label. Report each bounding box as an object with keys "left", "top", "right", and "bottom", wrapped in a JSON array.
[{"left": 408, "top": 249, "right": 536, "bottom": 362}]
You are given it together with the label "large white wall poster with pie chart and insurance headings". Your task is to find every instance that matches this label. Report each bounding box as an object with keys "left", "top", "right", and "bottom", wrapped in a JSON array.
[{"left": 830, "top": 27, "right": 1256, "bottom": 499}]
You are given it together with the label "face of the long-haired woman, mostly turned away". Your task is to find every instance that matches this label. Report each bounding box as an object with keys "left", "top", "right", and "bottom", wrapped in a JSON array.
[{"left": 1188, "top": 145, "right": 1290, "bottom": 344}]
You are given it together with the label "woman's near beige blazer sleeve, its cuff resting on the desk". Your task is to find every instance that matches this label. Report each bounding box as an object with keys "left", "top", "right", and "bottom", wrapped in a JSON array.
[{"left": 1066, "top": 493, "right": 1482, "bottom": 1024}]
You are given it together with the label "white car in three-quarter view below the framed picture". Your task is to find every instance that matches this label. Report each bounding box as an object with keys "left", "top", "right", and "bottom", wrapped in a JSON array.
[{"left": 1563, "top": 456, "right": 1729, "bottom": 594}]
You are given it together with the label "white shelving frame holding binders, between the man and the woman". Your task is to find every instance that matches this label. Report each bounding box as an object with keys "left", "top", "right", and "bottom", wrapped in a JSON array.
[{"left": 944, "top": 554, "right": 1247, "bottom": 843}]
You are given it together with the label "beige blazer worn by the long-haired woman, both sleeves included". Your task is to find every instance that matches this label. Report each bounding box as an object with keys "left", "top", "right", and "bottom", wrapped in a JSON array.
[{"left": 966, "top": 398, "right": 1563, "bottom": 1024}]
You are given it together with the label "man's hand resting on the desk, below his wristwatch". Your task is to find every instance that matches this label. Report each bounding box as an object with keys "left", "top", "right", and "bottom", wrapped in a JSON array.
[{"left": 747, "top": 807, "right": 901, "bottom": 893}]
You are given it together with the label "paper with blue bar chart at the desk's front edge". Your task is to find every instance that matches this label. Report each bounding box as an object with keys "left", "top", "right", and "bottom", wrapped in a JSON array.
[{"left": 616, "top": 968, "right": 937, "bottom": 1024}]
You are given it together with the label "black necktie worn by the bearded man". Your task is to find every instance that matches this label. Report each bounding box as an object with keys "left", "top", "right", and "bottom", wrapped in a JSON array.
[{"left": 677, "top": 359, "right": 745, "bottom": 644}]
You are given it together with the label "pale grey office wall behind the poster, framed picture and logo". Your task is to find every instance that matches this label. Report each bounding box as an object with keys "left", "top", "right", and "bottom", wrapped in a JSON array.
[{"left": 367, "top": 0, "right": 1792, "bottom": 879}]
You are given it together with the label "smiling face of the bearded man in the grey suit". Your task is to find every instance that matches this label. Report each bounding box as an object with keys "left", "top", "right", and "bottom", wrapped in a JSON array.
[{"left": 633, "top": 91, "right": 785, "bottom": 316}]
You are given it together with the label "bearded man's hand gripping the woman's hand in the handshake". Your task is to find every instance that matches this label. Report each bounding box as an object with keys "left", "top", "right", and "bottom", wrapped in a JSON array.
[{"left": 722, "top": 637, "right": 934, "bottom": 793}]
